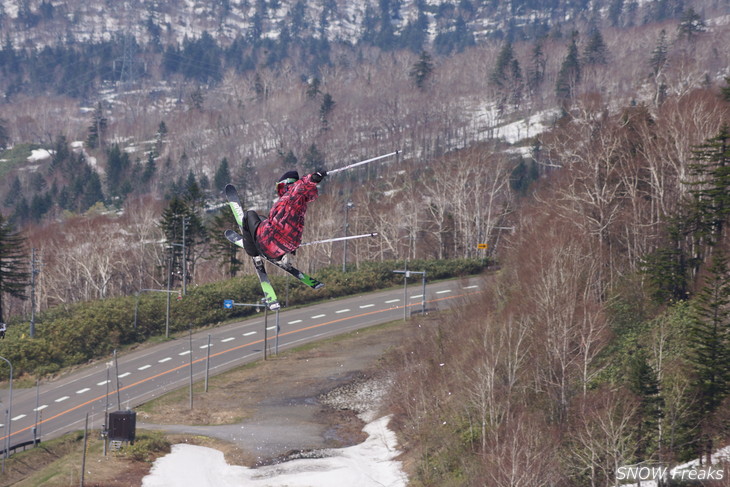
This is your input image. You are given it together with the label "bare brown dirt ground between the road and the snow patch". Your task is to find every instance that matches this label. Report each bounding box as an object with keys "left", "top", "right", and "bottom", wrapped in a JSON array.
[{"left": 137, "top": 322, "right": 408, "bottom": 467}]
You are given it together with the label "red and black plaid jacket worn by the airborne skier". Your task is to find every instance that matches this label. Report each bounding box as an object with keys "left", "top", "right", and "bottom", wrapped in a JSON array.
[{"left": 256, "top": 174, "right": 318, "bottom": 259}]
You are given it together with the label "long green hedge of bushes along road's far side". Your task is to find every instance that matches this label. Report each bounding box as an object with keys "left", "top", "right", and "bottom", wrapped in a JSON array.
[{"left": 0, "top": 259, "right": 483, "bottom": 377}]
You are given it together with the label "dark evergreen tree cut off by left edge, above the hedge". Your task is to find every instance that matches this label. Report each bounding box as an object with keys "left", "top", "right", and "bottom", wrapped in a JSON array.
[{"left": 0, "top": 214, "right": 29, "bottom": 323}]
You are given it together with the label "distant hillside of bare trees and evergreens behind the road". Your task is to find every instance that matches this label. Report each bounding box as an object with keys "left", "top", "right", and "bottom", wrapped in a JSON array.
[{"left": 0, "top": 2, "right": 728, "bottom": 316}]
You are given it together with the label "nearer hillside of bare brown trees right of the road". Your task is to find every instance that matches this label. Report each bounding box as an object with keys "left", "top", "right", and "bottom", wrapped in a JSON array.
[{"left": 391, "top": 87, "right": 730, "bottom": 486}]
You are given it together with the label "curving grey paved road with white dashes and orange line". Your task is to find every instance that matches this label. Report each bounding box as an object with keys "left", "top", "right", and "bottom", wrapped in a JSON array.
[{"left": 0, "top": 277, "right": 484, "bottom": 449}]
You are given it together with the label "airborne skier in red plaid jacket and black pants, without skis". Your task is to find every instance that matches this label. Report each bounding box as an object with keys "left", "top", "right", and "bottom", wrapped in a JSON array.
[{"left": 236, "top": 169, "right": 327, "bottom": 260}]
